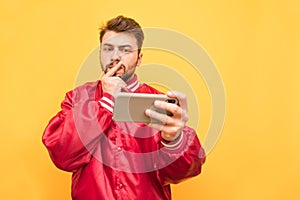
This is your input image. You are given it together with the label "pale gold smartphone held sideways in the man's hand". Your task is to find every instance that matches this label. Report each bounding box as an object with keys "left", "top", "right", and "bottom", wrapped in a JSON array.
[{"left": 113, "top": 92, "right": 178, "bottom": 123}]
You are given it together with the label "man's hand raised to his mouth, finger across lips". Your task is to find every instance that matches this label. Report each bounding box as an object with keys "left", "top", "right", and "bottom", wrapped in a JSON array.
[{"left": 101, "top": 61, "right": 128, "bottom": 95}]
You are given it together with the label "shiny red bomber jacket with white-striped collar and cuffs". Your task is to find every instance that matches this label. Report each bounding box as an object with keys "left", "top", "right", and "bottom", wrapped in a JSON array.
[{"left": 43, "top": 76, "right": 205, "bottom": 200}]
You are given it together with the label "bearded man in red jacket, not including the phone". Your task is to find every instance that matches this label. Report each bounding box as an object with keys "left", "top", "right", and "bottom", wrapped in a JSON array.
[{"left": 43, "top": 16, "right": 205, "bottom": 200}]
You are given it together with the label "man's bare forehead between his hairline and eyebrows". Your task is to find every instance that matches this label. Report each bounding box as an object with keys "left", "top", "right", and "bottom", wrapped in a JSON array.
[{"left": 102, "top": 31, "right": 137, "bottom": 46}]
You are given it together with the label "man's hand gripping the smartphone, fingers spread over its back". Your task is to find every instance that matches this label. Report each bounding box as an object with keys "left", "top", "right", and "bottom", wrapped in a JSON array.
[{"left": 146, "top": 91, "right": 188, "bottom": 141}]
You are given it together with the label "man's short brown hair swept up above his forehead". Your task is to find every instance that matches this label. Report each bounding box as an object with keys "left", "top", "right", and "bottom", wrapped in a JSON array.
[{"left": 100, "top": 15, "right": 144, "bottom": 53}]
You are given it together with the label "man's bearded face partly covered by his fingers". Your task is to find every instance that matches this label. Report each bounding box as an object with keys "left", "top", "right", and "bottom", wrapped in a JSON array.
[{"left": 100, "top": 31, "right": 142, "bottom": 82}]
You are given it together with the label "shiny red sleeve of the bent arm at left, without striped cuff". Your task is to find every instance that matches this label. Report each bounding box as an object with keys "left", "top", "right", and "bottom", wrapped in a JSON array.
[{"left": 42, "top": 86, "right": 112, "bottom": 172}]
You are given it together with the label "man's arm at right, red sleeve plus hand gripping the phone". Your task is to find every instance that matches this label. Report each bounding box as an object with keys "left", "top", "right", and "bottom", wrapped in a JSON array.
[{"left": 146, "top": 91, "right": 205, "bottom": 184}]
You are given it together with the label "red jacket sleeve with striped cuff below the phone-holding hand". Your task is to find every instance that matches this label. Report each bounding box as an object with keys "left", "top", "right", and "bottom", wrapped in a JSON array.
[{"left": 158, "top": 127, "right": 206, "bottom": 185}]
